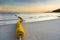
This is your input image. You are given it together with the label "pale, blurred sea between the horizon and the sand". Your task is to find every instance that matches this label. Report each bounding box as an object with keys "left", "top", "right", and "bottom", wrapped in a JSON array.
[{"left": 0, "top": 12, "right": 60, "bottom": 25}]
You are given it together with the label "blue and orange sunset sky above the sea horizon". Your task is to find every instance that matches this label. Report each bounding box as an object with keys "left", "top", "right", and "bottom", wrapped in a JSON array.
[{"left": 0, "top": 0, "right": 60, "bottom": 12}]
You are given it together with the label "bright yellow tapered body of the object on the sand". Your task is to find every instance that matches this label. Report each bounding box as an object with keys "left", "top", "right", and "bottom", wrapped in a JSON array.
[{"left": 16, "top": 20, "right": 24, "bottom": 38}]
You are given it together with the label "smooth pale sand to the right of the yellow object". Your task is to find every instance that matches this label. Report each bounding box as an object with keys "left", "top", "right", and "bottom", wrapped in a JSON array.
[{"left": 23, "top": 18, "right": 60, "bottom": 40}]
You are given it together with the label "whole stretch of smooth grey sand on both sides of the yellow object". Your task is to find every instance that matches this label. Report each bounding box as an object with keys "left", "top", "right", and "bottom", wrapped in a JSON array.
[{"left": 0, "top": 18, "right": 60, "bottom": 40}]
